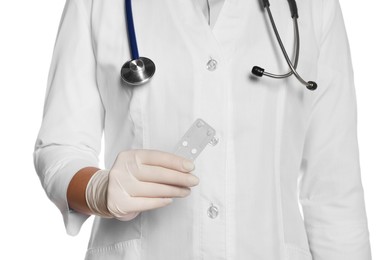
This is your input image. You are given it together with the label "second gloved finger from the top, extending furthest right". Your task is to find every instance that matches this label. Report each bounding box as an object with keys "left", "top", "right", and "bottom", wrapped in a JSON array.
[{"left": 133, "top": 165, "right": 199, "bottom": 187}]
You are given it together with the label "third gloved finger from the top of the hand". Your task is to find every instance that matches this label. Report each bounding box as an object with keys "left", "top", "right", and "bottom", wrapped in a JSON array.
[{"left": 128, "top": 181, "right": 191, "bottom": 198}]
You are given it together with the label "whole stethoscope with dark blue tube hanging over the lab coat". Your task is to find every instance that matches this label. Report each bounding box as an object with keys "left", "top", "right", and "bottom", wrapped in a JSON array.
[{"left": 121, "top": 0, "right": 317, "bottom": 90}]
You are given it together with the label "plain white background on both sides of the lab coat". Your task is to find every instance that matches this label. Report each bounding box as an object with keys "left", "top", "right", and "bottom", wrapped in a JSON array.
[{"left": 0, "top": 0, "right": 390, "bottom": 260}]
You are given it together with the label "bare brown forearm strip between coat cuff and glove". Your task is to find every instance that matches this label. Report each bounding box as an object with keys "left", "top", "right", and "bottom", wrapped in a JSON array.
[{"left": 66, "top": 167, "right": 99, "bottom": 215}]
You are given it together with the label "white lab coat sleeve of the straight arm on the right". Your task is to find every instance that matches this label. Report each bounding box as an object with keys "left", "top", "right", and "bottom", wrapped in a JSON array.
[{"left": 299, "top": 0, "right": 371, "bottom": 260}]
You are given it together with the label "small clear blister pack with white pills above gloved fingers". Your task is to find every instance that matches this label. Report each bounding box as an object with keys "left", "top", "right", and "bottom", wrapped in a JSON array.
[{"left": 174, "top": 119, "right": 215, "bottom": 161}]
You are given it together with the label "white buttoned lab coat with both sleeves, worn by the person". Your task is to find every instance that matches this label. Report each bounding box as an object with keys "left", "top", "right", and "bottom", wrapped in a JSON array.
[{"left": 35, "top": 0, "right": 371, "bottom": 260}]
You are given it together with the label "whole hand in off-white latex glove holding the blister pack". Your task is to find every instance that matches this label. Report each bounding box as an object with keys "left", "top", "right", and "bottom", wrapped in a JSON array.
[{"left": 85, "top": 150, "right": 199, "bottom": 221}]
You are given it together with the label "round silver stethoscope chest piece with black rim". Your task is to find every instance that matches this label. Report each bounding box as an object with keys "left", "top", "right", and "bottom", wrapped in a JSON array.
[{"left": 121, "top": 57, "right": 156, "bottom": 86}]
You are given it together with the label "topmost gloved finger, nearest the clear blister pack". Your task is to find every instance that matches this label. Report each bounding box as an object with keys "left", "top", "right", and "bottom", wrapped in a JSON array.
[{"left": 135, "top": 150, "right": 195, "bottom": 172}]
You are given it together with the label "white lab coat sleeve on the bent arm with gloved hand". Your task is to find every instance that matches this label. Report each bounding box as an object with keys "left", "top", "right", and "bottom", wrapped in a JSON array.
[{"left": 34, "top": 0, "right": 104, "bottom": 235}]
